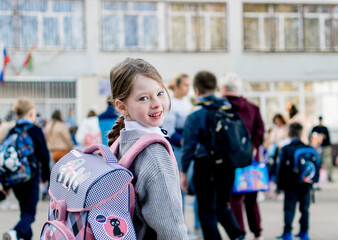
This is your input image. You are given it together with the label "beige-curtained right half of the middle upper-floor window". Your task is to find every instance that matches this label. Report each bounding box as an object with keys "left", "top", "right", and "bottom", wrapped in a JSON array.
[{"left": 168, "top": 3, "right": 227, "bottom": 51}]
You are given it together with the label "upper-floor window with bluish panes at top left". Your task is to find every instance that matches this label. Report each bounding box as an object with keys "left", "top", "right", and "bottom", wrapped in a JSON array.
[{"left": 0, "top": 0, "right": 85, "bottom": 49}]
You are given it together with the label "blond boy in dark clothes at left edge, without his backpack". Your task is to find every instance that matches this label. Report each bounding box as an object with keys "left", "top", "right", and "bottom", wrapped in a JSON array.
[{"left": 3, "top": 98, "right": 50, "bottom": 240}]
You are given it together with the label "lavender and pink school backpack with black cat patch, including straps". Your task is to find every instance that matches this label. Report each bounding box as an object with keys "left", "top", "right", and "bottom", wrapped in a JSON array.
[{"left": 40, "top": 133, "right": 175, "bottom": 240}]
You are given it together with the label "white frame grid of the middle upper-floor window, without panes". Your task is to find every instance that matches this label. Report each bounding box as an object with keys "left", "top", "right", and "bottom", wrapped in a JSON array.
[{"left": 101, "top": 1, "right": 227, "bottom": 52}]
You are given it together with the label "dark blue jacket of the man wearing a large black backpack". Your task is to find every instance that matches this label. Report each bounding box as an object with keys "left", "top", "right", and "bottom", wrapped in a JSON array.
[{"left": 182, "top": 95, "right": 229, "bottom": 173}]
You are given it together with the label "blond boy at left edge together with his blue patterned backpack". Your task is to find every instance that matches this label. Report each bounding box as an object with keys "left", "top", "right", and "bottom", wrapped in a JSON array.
[{"left": 1, "top": 98, "right": 50, "bottom": 240}]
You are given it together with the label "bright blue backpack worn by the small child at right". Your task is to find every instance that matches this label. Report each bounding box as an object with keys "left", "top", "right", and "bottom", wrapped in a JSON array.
[{"left": 293, "top": 147, "right": 320, "bottom": 183}]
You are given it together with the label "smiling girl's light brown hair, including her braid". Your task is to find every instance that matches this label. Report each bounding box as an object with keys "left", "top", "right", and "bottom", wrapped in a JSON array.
[{"left": 108, "top": 58, "right": 170, "bottom": 146}]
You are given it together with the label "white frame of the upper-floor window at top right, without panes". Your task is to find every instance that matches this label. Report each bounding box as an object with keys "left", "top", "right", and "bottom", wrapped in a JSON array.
[{"left": 242, "top": 2, "right": 338, "bottom": 53}]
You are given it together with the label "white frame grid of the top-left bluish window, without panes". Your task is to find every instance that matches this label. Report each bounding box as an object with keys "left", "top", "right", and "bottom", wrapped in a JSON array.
[{"left": 0, "top": 0, "right": 85, "bottom": 50}]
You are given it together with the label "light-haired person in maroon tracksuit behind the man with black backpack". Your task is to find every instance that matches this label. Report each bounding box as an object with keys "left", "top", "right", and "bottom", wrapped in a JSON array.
[{"left": 220, "top": 73, "right": 264, "bottom": 240}]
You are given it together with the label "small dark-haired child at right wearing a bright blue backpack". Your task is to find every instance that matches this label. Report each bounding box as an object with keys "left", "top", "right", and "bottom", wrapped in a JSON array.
[{"left": 277, "top": 122, "right": 319, "bottom": 240}]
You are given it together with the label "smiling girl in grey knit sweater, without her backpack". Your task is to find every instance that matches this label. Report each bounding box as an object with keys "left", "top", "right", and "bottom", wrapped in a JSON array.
[{"left": 108, "top": 58, "right": 188, "bottom": 239}]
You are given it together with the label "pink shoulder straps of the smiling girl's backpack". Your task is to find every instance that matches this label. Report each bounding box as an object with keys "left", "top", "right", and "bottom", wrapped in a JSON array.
[{"left": 110, "top": 133, "right": 178, "bottom": 173}]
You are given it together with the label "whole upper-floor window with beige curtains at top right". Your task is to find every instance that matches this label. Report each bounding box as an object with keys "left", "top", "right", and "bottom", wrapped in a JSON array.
[{"left": 243, "top": 3, "right": 338, "bottom": 51}]
